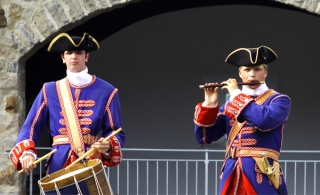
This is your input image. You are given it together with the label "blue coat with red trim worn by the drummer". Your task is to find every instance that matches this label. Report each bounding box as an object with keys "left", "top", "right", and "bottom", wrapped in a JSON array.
[{"left": 9, "top": 76, "right": 125, "bottom": 174}]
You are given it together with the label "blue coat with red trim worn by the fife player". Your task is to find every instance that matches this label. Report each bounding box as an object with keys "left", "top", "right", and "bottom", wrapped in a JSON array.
[{"left": 194, "top": 89, "right": 291, "bottom": 195}]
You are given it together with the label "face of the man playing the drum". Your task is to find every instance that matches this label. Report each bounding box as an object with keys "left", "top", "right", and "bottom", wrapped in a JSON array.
[{"left": 61, "top": 50, "right": 89, "bottom": 72}]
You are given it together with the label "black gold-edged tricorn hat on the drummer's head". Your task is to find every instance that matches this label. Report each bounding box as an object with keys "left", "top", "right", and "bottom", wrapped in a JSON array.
[{"left": 47, "top": 33, "right": 100, "bottom": 53}]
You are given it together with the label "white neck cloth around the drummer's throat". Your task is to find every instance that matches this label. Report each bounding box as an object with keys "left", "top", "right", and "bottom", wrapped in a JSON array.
[{"left": 67, "top": 67, "right": 92, "bottom": 86}]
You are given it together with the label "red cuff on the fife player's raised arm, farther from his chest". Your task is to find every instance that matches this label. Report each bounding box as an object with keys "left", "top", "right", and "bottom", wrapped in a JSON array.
[{"left": 194, "top": 102, "right": 219, "bottom": 127}]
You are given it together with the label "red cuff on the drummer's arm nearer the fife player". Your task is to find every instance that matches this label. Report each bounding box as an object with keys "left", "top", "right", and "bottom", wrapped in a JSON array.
[{"left": 100, "top": 136, "right": 122, "bottom": 167}]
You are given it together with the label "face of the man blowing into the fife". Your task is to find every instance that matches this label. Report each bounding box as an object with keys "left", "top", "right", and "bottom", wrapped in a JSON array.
[{"left": 239, "top": 65, "right": 268, "bottom": 89}]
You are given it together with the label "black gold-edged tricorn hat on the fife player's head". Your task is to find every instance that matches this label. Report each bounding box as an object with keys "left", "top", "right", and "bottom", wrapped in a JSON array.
[{"left": 225, "top": 46, "right": 278, "bottom": 67}]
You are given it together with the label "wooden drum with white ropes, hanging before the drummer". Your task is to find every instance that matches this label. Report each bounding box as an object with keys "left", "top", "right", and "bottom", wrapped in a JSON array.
[{"left": 38, "top": 159, "right": 113, "bottom": 195}]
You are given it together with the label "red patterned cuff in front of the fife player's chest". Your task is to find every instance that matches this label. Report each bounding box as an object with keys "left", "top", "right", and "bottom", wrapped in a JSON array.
[{"left": 225, "top": 93, "right": 253, "bottom": 119}]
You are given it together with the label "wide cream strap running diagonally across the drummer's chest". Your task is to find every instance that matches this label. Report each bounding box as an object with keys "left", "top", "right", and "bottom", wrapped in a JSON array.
[{"left": 58, "top": 78, "right": 84, "bottom": 155}]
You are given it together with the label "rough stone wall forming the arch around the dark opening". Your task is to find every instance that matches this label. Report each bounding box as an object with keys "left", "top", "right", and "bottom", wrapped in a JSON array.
[{"left": 0, "top": 0, "right": 320, "bottom": 194}]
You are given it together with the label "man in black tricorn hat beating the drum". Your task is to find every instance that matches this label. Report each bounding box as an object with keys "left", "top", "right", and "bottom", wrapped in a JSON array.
[{"left": 9, "top": 33, "right": 125, "bottom": 183}]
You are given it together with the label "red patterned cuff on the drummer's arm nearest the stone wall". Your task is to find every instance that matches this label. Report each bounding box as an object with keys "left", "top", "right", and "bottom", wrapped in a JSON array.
[{"left": 9, "top": 140, "right": 38, "bottom": 171}]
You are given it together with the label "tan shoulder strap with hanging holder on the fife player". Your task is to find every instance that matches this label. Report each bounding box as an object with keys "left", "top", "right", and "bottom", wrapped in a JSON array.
[{"left": 225, "top": 89, "right": 280, "bottom": 190}]
